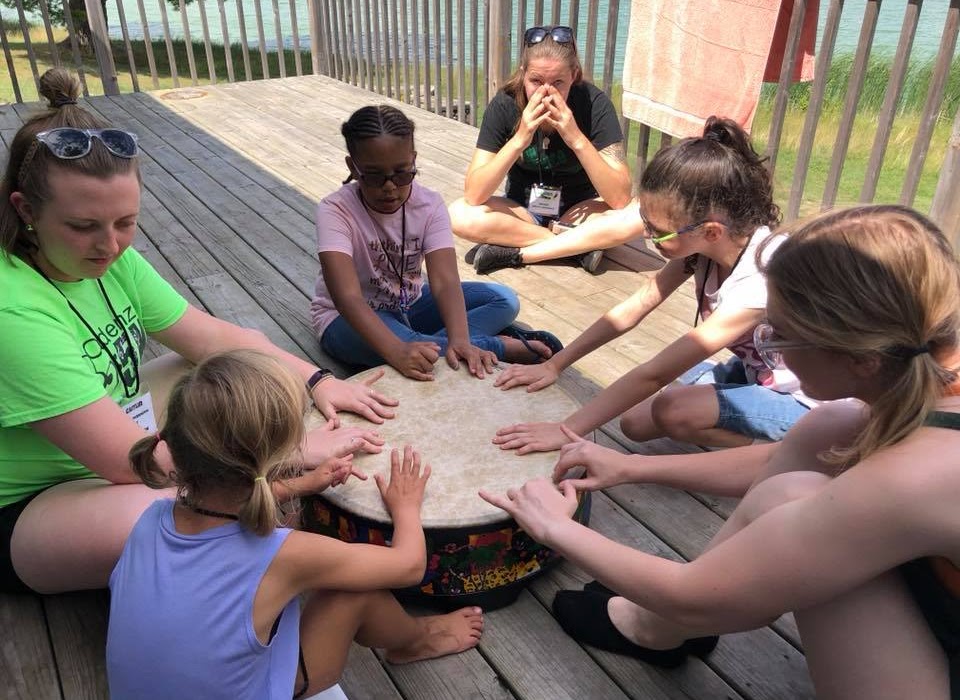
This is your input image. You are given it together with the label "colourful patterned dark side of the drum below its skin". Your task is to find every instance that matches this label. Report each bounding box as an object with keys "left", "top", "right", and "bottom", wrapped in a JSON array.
[{"left": 302, "top": 492, "right": 590, "bottom": 610}]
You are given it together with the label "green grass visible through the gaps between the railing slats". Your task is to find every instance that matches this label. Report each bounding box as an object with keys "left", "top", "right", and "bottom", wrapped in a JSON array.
[{"left": 0, "top": 23, "right": 960, "bottom": 214}]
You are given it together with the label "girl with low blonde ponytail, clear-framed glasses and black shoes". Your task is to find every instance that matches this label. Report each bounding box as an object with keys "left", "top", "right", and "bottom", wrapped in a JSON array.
[{"left": 486, "top": 205, "right": 960, "bottom": 700}]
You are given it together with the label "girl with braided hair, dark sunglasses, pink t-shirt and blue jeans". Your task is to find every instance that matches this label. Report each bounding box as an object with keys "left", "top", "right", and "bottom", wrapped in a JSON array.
[{"left": 311, "top": 105, "right": 563, "bottom": 380}]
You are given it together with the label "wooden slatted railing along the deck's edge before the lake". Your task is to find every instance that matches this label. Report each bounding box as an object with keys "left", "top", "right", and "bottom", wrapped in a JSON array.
[{"left": 0, "top": 0, "right": 960, "bottom": 238}]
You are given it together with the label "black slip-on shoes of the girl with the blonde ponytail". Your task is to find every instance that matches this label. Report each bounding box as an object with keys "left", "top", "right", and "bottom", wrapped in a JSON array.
[{"left": 553, "top": 590, "right": 720, "bottom": 668}]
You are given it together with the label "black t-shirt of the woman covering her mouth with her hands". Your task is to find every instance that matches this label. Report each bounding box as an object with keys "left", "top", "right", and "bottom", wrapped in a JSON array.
[{"left": 477, "top": 82, "right": 623, "bottom": 213}]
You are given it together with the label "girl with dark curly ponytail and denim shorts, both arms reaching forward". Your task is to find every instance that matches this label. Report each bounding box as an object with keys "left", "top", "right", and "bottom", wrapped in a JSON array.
[{"left": 488, "top": 117, "right": 815, "bottom": 453}]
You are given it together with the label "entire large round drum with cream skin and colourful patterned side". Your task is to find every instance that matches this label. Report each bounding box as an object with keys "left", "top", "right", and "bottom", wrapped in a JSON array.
[{"left": 303, "top": 358, "right": 590, "bottom": 610}]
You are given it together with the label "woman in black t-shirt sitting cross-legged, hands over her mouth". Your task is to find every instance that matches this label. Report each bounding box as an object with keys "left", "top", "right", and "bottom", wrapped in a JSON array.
[{"left": 450, "top": 27, "right": 630, "bottom": 270}]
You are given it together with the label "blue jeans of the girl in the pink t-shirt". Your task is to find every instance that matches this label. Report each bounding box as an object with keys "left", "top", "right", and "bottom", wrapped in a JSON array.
[{"left": 320, "top": 282, "right": 520, "bottom": 367}]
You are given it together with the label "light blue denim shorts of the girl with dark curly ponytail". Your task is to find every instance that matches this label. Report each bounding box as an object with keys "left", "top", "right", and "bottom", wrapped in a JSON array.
[{"left": 679, "top": 357, "right": 810, "bottom": 440}]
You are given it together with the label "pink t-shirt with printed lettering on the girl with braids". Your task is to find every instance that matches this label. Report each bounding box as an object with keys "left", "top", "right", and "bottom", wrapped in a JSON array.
[{"left": 310, "top": 182, "right": 453, "bottom": 336}]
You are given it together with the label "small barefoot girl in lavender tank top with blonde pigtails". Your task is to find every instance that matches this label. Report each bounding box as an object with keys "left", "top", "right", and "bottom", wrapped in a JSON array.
[{"left": 107, "top": 350, "right": 483, "bottom": 700}]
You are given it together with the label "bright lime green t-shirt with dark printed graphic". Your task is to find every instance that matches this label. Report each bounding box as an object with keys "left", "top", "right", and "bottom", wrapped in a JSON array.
[{"left": 0, "top": 248, "right": 187, "bottom": 506}]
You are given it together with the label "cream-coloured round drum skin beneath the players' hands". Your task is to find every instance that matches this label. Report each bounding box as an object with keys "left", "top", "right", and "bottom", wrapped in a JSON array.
[{"left": 308, "top": 364, "right": 579, "bottom": 528}]
